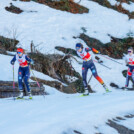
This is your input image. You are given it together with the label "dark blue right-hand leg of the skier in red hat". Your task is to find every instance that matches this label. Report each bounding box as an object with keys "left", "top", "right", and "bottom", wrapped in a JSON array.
[{"left": 24, "top": 67, "right": 30, "bottom": 93}]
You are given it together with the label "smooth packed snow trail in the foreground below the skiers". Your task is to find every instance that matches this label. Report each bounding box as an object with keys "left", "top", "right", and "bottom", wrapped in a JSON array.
[{"left": 0, "top": 89, "right": 134, "bottom": 134}]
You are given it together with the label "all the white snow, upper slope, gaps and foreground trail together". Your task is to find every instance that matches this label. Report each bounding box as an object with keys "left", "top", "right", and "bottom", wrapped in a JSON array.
[{"left": 0, "top": 0, "right": 134, "bottom": 134}]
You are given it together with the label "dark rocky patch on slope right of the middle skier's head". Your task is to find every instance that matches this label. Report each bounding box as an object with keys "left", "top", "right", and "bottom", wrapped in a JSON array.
[{"left": 79, "top": 33, "right": 134, "bottom": 59}]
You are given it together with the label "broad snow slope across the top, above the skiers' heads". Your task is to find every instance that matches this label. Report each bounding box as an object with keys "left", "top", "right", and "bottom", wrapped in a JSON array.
[{"left": 0, "top": 0, "right": 134, "bottom": 53}]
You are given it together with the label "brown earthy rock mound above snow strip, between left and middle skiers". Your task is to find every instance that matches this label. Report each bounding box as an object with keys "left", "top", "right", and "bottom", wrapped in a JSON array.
[{"left": 28, "top": 53, "right": 81, "bottom": 83}]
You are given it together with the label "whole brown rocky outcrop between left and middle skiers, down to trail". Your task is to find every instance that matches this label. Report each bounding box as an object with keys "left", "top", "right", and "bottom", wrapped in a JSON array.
[{"left": 29, "top": 53, "right": 90, "bottom": 93}]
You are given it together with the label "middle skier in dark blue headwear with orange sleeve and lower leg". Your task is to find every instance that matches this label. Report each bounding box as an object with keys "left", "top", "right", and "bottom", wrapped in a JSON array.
[{"left": 76, "top": 43, "right": 109, "bottom": 95}]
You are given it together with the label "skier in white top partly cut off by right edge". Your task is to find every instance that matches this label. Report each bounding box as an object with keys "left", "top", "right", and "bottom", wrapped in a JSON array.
[{"left": 125, "top": 47, "right": 134, "bottom": 88}]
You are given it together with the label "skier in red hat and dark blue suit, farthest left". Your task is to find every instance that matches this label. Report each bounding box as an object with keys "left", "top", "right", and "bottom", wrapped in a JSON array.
[{"left": 11, "top": 48, "right": 33, "bottom": 99}]
